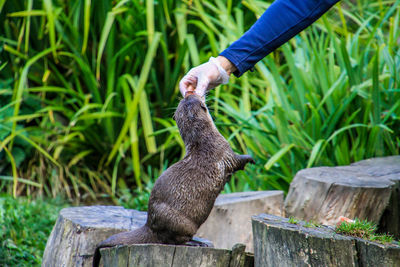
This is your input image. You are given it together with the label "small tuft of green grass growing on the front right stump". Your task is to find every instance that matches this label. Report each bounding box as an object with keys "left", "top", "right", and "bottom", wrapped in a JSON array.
[{"left": 335, "top": 218, "right": 393, "bottom": 244}]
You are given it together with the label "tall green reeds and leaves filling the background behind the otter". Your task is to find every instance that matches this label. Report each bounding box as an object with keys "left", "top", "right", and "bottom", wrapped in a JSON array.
[{"left": 0, "top": 0, "right": 400, "bottom": 264}]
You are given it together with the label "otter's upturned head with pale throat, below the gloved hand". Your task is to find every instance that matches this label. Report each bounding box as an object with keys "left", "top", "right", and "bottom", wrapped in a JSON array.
[{"left": 174, "top": 94, "right": 216, "bottom": 144}]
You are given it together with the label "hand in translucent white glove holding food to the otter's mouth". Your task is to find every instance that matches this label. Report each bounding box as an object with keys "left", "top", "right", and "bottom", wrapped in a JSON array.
[{"left": 179, "top": 56, "right": 236, "bottom": 97}]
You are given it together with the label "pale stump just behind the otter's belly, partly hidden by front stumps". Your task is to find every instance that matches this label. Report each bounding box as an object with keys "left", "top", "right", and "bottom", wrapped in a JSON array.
[{"left": 197, "top": 191, "right": 284, "bottom": 252}]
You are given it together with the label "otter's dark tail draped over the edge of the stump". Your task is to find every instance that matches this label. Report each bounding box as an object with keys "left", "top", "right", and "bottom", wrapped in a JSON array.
[{"left": 92, "top": 225, "right": 161, "bottom": 267}]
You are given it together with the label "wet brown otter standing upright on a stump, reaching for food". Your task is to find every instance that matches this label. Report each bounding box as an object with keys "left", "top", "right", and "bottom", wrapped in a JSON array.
[{"left": 93, "top": 91, "right": 254, "bottom": 267}]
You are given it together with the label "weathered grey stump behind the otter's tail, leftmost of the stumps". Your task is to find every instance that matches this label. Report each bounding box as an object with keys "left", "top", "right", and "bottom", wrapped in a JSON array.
[{"left": 42, "top": 206, "right": 147, "bottom": 267}]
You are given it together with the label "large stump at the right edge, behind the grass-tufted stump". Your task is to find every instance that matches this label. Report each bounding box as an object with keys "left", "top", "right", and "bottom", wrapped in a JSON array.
[{"left": 285, "top": 156, "right": 400, "bottom": 229}]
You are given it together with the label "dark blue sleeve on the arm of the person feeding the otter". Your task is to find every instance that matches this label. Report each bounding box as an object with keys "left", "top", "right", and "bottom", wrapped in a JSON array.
[{"left": 220, "top": 0, "right": 339, "bottom": 77}]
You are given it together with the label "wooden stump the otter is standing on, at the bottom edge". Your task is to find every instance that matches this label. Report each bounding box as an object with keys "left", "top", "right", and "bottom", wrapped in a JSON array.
[{"left": 100, "top": 244, "right": 254, "bottom": 267}]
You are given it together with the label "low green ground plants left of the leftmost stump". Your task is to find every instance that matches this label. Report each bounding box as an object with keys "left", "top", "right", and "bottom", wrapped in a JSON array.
[{"left": 0, "top": 195, "right": 64, "bottom": 266}]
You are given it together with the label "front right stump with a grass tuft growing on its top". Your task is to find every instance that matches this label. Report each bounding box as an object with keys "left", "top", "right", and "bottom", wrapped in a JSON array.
[{"left": 252, "top": 214, "right": 400, "bottom": 267}]
